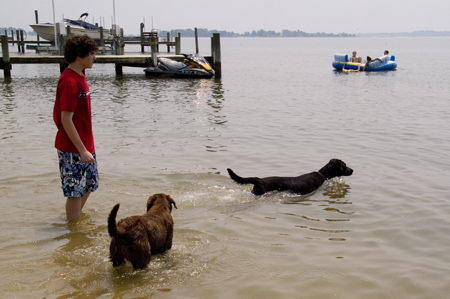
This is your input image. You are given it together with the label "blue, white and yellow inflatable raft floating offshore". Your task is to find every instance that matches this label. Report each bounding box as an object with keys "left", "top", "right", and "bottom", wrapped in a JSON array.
[{"left": 332, "top": 54, "right": 397, "bottom": 72}]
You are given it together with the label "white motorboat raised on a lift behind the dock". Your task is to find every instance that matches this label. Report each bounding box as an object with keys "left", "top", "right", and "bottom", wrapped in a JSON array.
[{"left": 30, "top": 13, "right": 113, "bottom": 41}]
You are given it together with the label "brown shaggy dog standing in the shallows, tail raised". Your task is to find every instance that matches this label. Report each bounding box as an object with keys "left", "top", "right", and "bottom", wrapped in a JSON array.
[{"left": 108, "top": 194, "right": 177, "bottom": 269}]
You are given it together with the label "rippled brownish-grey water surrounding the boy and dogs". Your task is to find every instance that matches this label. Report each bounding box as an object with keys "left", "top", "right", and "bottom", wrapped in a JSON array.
[{"left": 0, "top": 38, "right": 450, "bottom": 298}]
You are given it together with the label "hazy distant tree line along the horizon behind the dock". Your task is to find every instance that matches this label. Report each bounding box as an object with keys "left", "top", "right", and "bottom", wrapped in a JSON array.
[{"left": 159, "top": 28, "right": 355, "bottom": 37}]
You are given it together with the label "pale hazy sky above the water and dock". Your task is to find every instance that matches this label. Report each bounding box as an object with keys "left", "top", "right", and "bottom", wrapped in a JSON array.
[{"left": 0, "top": 0, "right": 450, "bottom": 35}]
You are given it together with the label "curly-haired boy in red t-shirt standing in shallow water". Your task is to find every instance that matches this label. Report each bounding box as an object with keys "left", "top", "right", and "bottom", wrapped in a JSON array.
[{"left": 53, "top": 35, "right": 99, "bottom": 220}]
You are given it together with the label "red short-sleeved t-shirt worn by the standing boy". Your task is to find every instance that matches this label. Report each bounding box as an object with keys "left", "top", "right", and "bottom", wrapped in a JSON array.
[{"left": 53, "top": 68, "right": 95, "bottom": 153}]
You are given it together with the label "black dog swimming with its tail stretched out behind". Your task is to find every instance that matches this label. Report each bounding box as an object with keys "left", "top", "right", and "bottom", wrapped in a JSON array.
[{"left": 227, "top": 159, "right": 353, "bottom": 195}]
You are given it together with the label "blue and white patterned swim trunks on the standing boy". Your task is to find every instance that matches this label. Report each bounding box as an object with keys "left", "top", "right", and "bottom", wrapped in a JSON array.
[{"left": 58, "top": 150, "right": 98, "bottom": 197}]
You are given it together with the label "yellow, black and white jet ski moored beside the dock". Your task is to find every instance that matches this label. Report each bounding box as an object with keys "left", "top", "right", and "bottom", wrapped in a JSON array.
[{"left": 144, "top": 54, "right": 214, "bottom": 78}]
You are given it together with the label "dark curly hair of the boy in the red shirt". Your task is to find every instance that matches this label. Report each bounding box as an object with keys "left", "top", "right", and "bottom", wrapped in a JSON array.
[{"left": 64, "top": 34, "right": 98, "bottom": 63}]
